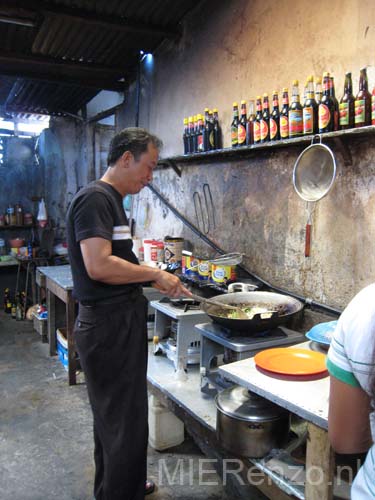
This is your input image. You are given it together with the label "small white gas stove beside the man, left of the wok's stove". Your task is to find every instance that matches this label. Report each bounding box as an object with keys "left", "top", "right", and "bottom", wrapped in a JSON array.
[{"left": 151, "top": 297, "right": 209, "bottom": 371}]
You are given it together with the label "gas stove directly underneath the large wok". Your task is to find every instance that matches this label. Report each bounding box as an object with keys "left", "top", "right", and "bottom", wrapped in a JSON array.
[{"left": 195, "top": 322, "right": 305, "bottom": 394}]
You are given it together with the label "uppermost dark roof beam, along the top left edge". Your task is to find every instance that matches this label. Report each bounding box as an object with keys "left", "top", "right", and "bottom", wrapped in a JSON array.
[{"left": 0, "top": 0, "right": 181, "bottom": 39}]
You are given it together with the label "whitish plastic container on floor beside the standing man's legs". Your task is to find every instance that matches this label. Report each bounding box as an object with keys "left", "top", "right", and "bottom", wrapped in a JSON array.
[{"left": 148, "top": 396, "right": 184, "bottom": 451}]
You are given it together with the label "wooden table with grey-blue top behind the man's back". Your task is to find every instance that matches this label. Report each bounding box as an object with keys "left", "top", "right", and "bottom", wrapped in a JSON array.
[{"left": 37, "top": 265, "right": 77, "bottom": 385}]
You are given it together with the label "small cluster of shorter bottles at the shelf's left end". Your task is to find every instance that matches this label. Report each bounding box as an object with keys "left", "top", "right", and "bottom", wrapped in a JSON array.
[{"left": 183, "top": 108, "right": 222, "bottom": 154}]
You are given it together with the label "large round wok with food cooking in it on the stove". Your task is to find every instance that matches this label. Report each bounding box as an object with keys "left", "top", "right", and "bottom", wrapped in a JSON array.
[{"left": 201, "top": 292, "right": 303, "bottom": 335}]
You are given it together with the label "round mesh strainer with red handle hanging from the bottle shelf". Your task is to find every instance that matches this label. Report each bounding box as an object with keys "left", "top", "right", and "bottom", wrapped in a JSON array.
[{"left": 293, "top": 135, "right": 336, "bottom": 257}]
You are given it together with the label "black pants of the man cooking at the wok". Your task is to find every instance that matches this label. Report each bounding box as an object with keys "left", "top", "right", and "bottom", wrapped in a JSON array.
[{"left": 75, "top": 293, "right": 148, "bottom": 500}]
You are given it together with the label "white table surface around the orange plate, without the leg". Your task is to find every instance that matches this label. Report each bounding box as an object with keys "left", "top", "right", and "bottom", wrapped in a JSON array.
[{"left": 219, "top": 342, "right": 329, "bottom": 430}]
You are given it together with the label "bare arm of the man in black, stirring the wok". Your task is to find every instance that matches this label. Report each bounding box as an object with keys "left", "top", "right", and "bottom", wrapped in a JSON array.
[{"left": 80, "top": 238, "right": 190, "bottom": 297}]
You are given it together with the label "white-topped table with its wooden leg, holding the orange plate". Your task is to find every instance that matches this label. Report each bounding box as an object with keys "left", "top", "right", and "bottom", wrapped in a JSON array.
[{"left": 219, "top": 342, "right": 335, "bottom": 500}]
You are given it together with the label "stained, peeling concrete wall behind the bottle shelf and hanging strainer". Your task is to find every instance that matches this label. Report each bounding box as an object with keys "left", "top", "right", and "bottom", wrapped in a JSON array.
[{"left": 135, "top": 0, "right": 375, "bottom": 307}]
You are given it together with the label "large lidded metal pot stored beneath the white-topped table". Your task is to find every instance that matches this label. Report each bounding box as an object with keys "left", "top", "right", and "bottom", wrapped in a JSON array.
[{"left": 215, "top": 385, "right": 290, "bottom": 458}]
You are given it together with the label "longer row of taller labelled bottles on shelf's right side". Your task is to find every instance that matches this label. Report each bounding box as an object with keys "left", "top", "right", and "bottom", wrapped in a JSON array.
[{"left": 231, "top": 68, "right": 375, "bottom": 147}]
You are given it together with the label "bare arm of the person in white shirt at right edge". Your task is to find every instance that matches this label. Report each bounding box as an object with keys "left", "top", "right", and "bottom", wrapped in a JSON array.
[{"left": 328, "top": 376, "right": 372, "bottom": 453}]
